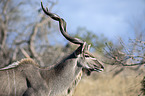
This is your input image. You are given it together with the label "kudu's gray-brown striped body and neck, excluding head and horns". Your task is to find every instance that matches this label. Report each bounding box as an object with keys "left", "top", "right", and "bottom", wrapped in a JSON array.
[{"left": 0, "top": 47, "right": 104, "bottom": 96}]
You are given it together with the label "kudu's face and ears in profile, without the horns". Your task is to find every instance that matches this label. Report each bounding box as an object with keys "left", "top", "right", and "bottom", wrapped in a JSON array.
[{"left": 74, "top": 42, "right": 104, "bottom": 75}]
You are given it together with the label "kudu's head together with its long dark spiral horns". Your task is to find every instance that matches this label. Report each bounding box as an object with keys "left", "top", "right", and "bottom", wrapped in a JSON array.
[{"left": 41, "top": 1, "right": 104, "bottom": 75}]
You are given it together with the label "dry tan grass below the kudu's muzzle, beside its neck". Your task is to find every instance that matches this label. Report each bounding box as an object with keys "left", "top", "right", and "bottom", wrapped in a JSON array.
[{"left": 74, "top": 68, "right": 143, "bottom": 96}]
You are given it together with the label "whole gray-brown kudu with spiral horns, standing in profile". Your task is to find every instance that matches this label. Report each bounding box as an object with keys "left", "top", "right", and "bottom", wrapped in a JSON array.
[{"left": 0, "top": 2, "right": 104, "bottom": 96}]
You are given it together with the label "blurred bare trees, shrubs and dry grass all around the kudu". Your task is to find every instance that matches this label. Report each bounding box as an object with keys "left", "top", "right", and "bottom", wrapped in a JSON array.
[{"left": 0, "top": 0, "right": 145, "bottom": 96}]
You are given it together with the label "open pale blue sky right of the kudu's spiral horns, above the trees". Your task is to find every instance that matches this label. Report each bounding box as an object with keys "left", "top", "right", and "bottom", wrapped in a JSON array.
[{"left": 48, "top": 0, "right": 145, "bottom": 40}]
